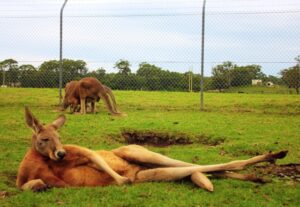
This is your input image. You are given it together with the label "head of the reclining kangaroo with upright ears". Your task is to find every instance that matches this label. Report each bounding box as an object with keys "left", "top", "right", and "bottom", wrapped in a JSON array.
[{"left": 25, "top": 107, "right": 66, "bottom": 160}]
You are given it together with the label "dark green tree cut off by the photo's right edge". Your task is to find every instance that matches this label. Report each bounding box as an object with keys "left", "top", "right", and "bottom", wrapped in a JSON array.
[{"left": 281, "top": 56, "right": 300, "bottom": 94}]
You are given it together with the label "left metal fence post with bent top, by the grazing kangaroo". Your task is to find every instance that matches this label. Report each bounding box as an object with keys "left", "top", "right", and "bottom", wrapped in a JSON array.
[{"left": 59, "top": 0, "right": 68, "bottom": 104}]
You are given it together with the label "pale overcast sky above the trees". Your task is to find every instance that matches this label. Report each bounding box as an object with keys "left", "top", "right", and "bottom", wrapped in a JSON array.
[{"left": 0, "top": 0, "right": 300, "bottom": 75}]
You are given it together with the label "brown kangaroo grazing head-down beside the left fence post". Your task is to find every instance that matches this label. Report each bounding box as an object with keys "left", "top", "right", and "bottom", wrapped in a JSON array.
[{"left": 64, "top": 77, "right": 122, "bottom": 115}]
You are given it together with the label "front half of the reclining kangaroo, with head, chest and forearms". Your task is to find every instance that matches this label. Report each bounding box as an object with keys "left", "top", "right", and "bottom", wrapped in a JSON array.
[{"left": 17, "top": 108, "right": 129, "bottom": 190}]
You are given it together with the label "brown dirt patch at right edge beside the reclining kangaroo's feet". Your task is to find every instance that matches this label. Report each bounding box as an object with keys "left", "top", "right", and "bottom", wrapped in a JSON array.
[{"left": 252, "top": 163, "right": 300, "bottom": 182}]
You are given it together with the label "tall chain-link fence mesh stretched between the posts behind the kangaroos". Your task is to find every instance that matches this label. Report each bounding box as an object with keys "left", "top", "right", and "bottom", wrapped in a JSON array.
[{"left": 0, "top": 0, "right": 300, "bottom": 93}]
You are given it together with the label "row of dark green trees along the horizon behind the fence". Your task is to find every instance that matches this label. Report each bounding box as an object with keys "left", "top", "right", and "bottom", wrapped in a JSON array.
[{"left": 0, "top": 56, "right": 300, "bottom": 93}]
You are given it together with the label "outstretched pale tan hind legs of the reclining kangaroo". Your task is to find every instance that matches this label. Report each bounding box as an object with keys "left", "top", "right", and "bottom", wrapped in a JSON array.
[{"left": 112, "top": 145, "right": 287, "bottom": 190}]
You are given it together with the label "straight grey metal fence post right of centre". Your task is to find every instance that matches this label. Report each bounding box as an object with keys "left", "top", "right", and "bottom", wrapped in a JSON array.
[{"left": 200, "top": 0, "right": 206, "bottom": 110}]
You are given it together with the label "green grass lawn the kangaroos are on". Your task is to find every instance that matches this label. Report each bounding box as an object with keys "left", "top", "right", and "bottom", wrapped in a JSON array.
[{"left": 0, "top": 88, "right": 300, "bottom": 207}]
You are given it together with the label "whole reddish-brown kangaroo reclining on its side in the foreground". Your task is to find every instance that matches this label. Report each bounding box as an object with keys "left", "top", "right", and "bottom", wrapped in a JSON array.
[{"left": 17, "top": 108, "right": 287, "bottom": 191}]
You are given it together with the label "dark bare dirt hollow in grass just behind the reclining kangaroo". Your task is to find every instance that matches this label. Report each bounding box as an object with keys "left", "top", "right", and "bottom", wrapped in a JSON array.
[{"left": 121, "top": 129, "right": 225, "bottom": 146}]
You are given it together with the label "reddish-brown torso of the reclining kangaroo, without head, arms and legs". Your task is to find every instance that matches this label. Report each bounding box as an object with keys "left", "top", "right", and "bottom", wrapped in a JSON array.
[{"left": 17, "top": 145, "right": 140, "bottom": 188}]
